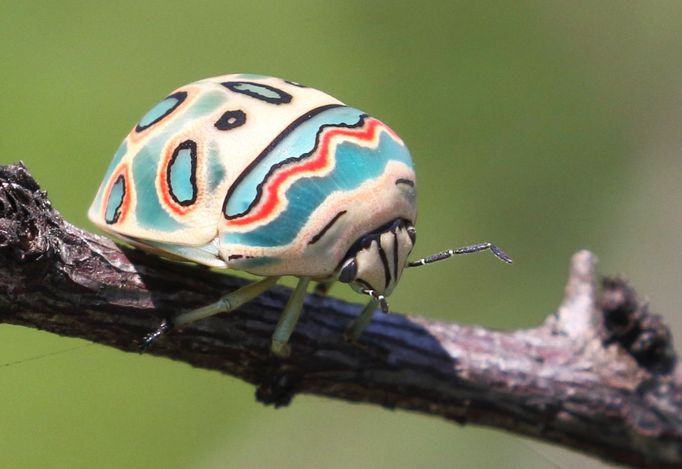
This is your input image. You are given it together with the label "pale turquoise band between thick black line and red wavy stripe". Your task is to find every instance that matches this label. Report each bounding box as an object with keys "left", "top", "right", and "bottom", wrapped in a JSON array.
[{"left": 225, "top": 106, "right": 364, "bottom": 216}]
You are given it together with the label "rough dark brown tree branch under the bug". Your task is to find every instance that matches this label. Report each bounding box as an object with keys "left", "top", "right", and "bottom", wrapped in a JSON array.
[{"left": 0, "top": 165, "right": 682, "bottom": 467}]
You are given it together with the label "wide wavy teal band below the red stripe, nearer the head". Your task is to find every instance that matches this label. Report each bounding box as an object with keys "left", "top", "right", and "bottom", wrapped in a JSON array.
[{"left": 221, "top": 133, "right": 413, "bottom": 247}]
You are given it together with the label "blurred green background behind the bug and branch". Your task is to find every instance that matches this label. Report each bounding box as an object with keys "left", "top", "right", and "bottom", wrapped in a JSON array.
[{"left": 0, "top": 0, "right": 682, "bottom": 469}]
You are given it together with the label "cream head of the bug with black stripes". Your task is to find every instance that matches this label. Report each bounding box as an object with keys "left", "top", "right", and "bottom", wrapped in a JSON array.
[{"left": 338, "top": 219, "right": 417, "bottom": 311}]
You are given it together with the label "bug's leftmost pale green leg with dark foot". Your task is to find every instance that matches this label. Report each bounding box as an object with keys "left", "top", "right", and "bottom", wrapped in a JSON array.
[{"left": 140, "top": 277, "right": 279, "bottom": 352}]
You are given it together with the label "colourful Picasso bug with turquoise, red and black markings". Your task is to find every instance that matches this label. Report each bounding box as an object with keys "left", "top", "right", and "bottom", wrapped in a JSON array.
[{"left": 88, "top": 74, "right": 511, "bottom": 356}]
